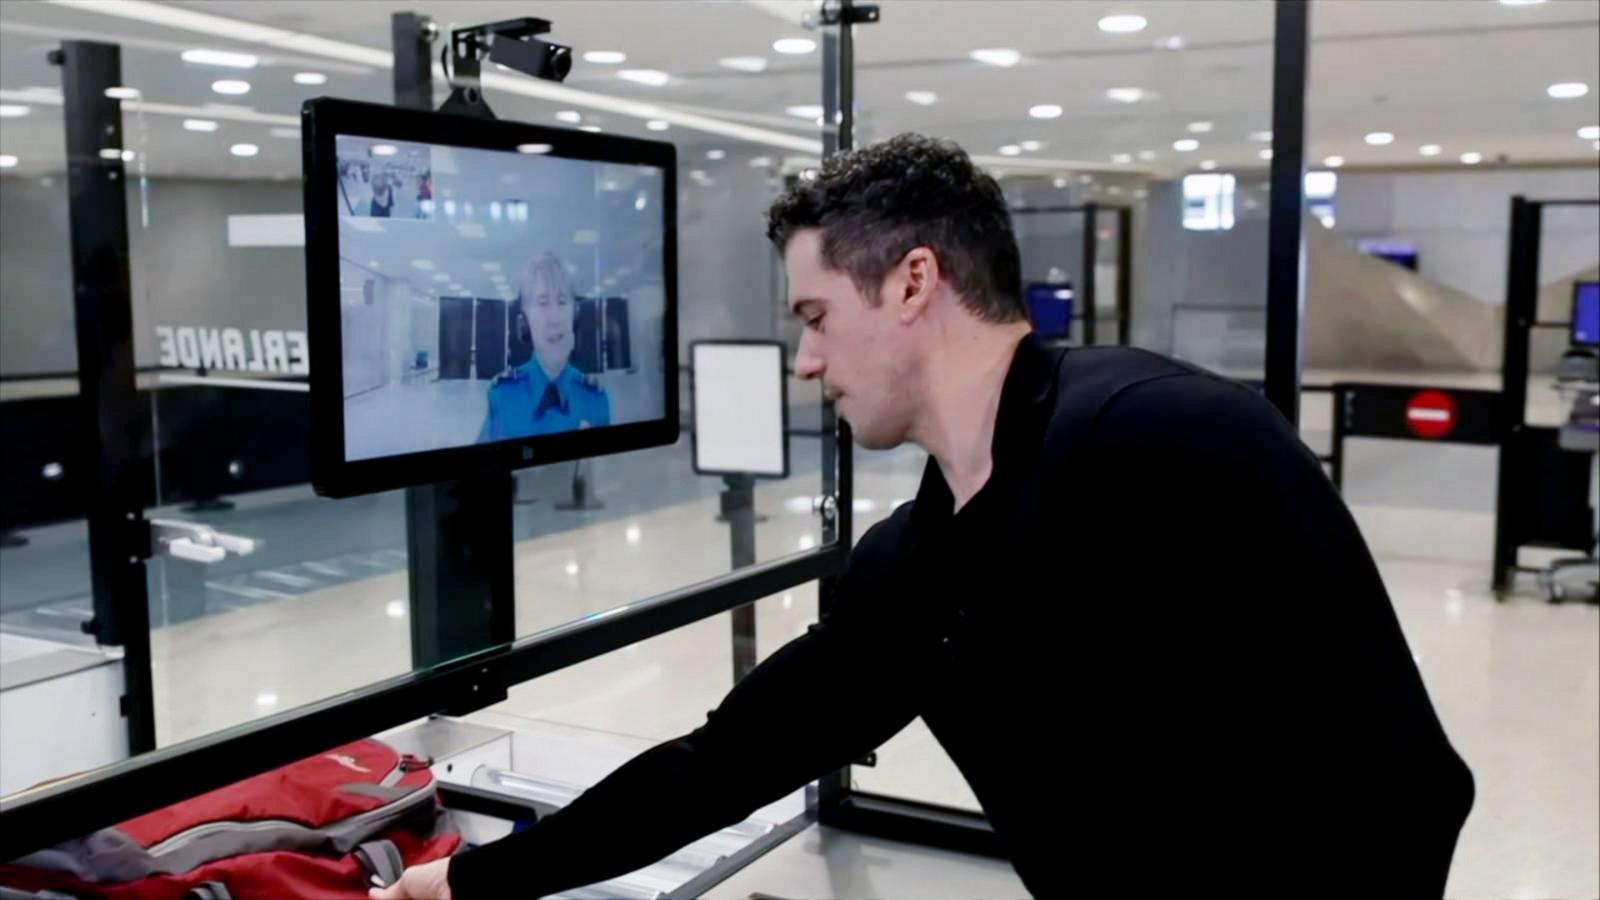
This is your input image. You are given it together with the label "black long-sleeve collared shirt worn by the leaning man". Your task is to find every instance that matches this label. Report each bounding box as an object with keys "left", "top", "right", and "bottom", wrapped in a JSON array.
[{"left": 450, "top": 336, "right": 1474, "bottom": 900}]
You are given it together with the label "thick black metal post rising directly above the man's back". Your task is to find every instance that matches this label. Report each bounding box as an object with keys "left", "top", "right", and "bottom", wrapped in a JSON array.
[{"left": 1266, "top": 0, "right": 1310, "bottom": 423}]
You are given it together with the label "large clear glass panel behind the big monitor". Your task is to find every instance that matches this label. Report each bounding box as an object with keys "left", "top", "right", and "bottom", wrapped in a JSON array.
[{"left": 0, "top": 2, "right": 826, "bottom": 807}]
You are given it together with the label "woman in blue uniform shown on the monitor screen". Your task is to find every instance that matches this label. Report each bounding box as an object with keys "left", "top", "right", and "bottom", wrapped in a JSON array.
[{"left": 478, "top": 253, "right": 611, "bottom": 444}]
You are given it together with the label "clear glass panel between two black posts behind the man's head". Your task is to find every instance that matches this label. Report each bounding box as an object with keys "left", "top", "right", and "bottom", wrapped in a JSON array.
[{"left": 842, "top": 2, "right": 1272, "bottom": 809}]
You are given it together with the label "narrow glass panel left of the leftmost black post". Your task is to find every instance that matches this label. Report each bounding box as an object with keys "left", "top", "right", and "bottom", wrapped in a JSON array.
[{"left": 0, "top": 27, "right": 128, "bottom": 796}]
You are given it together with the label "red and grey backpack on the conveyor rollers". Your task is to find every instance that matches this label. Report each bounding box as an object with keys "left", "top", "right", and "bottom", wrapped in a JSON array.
[{"left": 0, "top": 738, "right": 461, "bottom": 900}]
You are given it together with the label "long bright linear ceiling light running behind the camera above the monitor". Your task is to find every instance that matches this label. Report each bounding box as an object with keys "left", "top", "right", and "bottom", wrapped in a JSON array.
[{"left": 48, "top": 0, "right": 822, "bottom": 155}]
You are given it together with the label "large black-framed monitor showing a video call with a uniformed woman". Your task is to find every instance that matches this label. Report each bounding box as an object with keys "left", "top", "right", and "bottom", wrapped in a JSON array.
[{"left": 302, "top": 98, "right": 678, "bottom": 496}]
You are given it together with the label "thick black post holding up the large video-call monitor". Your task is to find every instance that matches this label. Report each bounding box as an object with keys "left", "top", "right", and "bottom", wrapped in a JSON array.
[{"left": 390, "top": 13, "right": 517, "bottom": 675}]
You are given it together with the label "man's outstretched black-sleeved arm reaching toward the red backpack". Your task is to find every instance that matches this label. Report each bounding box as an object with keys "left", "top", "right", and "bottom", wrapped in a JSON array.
[{"left": 409, "top": 566, "right": 931, "bottom": 900}]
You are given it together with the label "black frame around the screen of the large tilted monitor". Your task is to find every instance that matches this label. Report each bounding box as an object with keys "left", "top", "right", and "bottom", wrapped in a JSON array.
[{"left": 301, "top": 98, "right": 680, "bottom": 496}]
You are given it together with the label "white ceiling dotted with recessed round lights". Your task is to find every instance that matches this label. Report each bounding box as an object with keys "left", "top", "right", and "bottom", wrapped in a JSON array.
[{"left": 0, "top": 0, "right": 1600, "bottom": 178}]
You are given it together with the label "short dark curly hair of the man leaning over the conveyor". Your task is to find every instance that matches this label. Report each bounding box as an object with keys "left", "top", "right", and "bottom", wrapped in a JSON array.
[{"left": 766, "top": 133, "right": 1027, "bottom": 322}]
